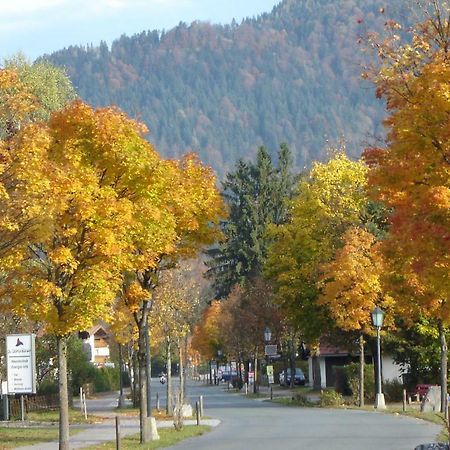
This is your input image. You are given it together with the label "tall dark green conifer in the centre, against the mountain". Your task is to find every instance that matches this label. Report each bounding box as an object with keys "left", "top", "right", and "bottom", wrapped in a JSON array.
[{"left": 207, "top": 144, "right": 295, "bottom": 298}]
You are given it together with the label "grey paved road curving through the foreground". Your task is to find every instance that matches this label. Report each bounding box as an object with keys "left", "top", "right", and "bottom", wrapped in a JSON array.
[{"left": 171, "top": 385, "right": 440, "bottom": 450}]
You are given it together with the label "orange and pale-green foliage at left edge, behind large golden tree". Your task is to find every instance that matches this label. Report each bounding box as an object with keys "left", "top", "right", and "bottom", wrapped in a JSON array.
[{"left": 0, "top": 55, "right": 75, "bottom": 270}]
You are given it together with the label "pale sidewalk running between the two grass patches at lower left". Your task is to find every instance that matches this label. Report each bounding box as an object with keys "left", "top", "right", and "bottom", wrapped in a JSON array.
[{"left": 17, "top": 417, "right": 220, "bottom": 450}]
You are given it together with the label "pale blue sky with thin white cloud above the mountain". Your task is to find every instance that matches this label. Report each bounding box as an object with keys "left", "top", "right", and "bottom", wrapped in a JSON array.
[{"left": 0, "top": 0, "right": 280, "bottom": 60}]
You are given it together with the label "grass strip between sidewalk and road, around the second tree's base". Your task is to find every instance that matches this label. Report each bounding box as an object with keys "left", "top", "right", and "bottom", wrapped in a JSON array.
[{"left": 86, "top": 425, "right": 211, "bottom": 450}]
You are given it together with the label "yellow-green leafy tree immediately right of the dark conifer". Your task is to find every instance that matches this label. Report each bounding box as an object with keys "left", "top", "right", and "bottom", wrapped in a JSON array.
[{"left": 265, "top": 152, "right": 367, "bottom": 343}]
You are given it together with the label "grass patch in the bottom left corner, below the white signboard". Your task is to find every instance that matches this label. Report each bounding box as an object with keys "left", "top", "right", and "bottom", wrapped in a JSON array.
[{"left": 0, "top": 426, "right": 82, "bottom": 450}]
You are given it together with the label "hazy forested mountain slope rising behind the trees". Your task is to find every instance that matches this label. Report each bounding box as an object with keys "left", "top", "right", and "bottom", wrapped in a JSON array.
[{"left": 40, "top": 0, "right": 411, "bottom": 175}]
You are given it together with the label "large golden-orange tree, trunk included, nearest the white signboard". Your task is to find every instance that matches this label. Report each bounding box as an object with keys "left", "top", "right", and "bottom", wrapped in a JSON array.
[{"left": 2, "top": 102, "right": 173, "bottom": 450}]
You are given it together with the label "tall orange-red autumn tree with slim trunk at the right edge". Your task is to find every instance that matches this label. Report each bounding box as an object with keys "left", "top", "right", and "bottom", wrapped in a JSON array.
[{"left": 365, "top": 1, "right": 450, "bottom": 410}]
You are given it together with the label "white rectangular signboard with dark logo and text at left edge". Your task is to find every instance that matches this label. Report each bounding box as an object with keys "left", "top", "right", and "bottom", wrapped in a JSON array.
[{"left": 6, "top": 334, "right": 36, "bottom": 394}]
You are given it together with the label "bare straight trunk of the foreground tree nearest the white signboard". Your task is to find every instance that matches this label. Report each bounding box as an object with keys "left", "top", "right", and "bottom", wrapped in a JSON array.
[{"left": 56, "top": 336, "right": 69, "bottom": 450}]
